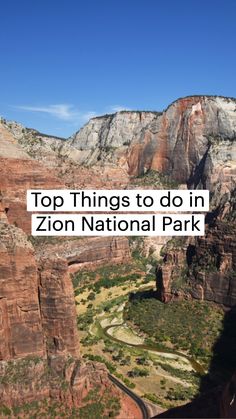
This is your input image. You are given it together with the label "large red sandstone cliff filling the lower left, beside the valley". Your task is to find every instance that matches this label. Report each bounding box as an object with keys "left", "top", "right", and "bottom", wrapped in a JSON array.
[{"left": 0, "top": 221, "right": 121, "bottom": 417}]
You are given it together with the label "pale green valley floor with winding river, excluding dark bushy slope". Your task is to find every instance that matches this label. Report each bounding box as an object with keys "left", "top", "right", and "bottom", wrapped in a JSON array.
[{"left": 74, "top": 265, "right": 223, "bottom": 409}]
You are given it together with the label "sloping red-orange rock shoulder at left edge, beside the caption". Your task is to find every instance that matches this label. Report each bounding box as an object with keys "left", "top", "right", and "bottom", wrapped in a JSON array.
[{"left": 0, "top": 124, "right": 64, "bottom": 234}]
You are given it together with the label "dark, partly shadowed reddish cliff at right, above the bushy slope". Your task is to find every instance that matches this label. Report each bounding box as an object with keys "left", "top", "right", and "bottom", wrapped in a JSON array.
[{"left": 156, "top": 221, "right": 236, "bottom": 307}]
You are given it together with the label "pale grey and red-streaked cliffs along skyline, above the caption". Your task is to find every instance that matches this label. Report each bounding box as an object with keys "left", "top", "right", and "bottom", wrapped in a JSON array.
[{"left": 0, "top": 96, "right": 236, "bottom": 218}]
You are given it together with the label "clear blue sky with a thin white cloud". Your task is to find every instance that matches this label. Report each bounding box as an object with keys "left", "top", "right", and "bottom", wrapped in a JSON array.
[{"left": 0, "top": 0, "right": 236, "bottom": 137}]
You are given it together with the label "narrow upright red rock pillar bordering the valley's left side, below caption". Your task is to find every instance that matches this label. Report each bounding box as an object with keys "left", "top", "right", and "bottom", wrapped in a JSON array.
[{"left": 38, "top": 257, "right": 79, "bottom": 357}]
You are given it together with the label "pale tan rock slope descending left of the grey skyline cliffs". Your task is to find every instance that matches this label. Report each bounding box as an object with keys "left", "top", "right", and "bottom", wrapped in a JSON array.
[{"left": 0, "top": 119, "right": 128, "bottom": 189}]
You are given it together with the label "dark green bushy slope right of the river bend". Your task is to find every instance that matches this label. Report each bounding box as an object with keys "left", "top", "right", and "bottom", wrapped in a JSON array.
[{"left": 124, "top": 294, "right": 224, "bottom": 365}]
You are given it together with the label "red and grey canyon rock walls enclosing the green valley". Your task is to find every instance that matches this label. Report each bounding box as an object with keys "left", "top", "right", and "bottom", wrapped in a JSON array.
[{"left": 0, "top": 96, "right": 236, "bottom": 418}]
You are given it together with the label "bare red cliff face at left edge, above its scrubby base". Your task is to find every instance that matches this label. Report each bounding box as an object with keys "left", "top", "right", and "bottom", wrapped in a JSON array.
[{"left": 0, "top": 222, "right": 45, "bottom": 360}]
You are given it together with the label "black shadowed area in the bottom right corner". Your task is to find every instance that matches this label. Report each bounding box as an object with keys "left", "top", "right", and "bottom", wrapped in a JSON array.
[{"left": 155, "top": 306, "right": 236, "bottom": 419}]
